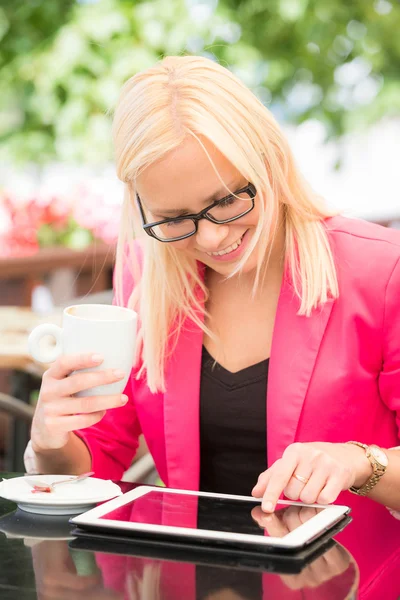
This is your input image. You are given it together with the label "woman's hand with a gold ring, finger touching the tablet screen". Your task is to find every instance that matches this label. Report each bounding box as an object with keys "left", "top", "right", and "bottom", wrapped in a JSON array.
[{"left": 252, "top": 442, "right": 372, "bottom": 512}]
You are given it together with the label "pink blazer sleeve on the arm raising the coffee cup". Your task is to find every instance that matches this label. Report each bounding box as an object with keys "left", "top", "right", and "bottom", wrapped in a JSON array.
[{"left": 74, "top": 243, "right": 146, "bottom": 480}]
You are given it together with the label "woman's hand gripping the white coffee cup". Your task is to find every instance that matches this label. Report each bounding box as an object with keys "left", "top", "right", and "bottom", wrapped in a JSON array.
[{"left": 31, "top": 355, "right": 128, "bottom": 451}]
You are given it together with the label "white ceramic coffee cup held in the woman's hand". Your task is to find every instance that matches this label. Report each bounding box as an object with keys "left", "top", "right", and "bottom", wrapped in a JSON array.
[{"left": 28, "top": 304, "right": 137, "bottom": 396}]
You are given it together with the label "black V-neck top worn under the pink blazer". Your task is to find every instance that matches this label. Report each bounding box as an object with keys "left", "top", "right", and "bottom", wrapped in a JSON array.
[{"left": 200, "top": 347, "right": 269, "bottom": 495}]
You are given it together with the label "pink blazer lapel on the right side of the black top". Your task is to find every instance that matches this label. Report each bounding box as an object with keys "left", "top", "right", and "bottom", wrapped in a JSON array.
[{"left": 267, "top": 273, "right": 334, "bottom": 466}]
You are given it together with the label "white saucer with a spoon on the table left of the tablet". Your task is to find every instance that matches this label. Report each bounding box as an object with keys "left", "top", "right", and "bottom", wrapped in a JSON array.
[{"left": 0, "top": 475, "right": 122, "bottom": 515}]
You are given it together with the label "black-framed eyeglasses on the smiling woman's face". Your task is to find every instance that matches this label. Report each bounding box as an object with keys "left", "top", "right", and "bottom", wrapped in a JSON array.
[{"left": 136, "top": 182, "right": 257, "bottom": 242}]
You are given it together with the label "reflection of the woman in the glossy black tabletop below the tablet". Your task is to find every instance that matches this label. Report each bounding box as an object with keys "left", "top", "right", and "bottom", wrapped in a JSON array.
[{"left": 32, "top": 541, "right": 358, "bottom": 600}]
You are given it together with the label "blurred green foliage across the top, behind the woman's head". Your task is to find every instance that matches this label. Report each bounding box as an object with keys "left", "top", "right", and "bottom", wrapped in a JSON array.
[{"left": 0, "top": 0, "right": 400, "bottom": 163}]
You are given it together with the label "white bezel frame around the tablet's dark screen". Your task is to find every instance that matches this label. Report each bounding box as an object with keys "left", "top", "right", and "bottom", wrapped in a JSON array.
[{"left": 70, "top": 486, "right": 350, "bottom": 549}]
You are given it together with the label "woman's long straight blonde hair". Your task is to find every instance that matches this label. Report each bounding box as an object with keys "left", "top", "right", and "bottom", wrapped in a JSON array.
[{"left": 113, "top": 56, "right": 338, "bottom": 392}]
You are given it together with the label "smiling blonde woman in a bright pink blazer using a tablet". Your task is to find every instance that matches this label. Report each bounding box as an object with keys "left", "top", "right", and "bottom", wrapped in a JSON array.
[{"left": 26, "top": 57, "right": 400, "bottom": 512}]
